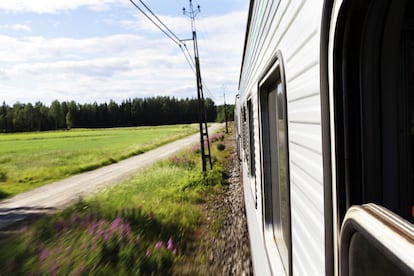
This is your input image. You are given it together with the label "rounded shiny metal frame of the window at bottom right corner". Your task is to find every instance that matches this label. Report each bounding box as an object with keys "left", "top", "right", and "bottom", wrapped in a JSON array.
[{"left": 340, "top": 203, "right": 414, "bottom": 275}]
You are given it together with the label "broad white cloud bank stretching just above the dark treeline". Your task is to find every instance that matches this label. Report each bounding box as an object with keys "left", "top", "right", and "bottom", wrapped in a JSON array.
[{"left": 0, "top": 8, "right": 246, "bottom": 104}]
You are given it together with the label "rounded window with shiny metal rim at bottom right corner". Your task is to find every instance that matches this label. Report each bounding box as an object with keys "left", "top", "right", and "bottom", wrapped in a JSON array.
[{"left": 340, "top": 204, "right": 414, "bottom": 276}]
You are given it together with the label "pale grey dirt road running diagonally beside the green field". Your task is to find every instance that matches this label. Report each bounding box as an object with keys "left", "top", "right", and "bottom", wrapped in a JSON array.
[{"left": 0, "top": 124, "right": 221, "bottom": 230}]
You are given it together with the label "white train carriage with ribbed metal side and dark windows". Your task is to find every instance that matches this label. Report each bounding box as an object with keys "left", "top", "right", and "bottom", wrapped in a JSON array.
[{"left": 235, "top": 0, "right": 414, "bottom": 276}]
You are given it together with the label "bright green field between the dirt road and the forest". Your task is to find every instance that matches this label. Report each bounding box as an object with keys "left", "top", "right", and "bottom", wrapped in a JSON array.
[{"left": 0, "top": 124, "right": 197, "bottom": 199}]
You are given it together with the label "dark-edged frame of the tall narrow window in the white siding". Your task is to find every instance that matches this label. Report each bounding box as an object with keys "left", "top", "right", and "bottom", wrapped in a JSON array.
[{"left": 257, "top": 51, "right": 292, "bottom": 275}]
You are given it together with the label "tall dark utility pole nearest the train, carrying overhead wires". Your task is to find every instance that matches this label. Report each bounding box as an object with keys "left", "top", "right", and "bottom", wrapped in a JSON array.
[{"left": 183, "top": 0, "right": 213, "bottom": 172}]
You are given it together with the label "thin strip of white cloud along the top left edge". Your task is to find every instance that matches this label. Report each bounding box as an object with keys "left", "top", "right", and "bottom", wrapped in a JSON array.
[{"left": 0, "top": 0, "right": 125, "bottom": 13}]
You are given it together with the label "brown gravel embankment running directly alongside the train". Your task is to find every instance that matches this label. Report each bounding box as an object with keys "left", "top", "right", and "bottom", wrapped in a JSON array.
[{"left": 179, "top": 135, "right": 253, "bottom": 275}]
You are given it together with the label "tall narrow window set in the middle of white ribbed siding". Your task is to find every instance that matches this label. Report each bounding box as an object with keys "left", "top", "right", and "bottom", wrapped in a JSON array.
[{"left": 259, "top": 51, "right": 291, "bottom": 274}]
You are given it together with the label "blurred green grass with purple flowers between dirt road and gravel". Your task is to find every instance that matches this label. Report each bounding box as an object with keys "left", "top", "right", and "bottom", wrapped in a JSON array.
[{"left": 0, "top": 129, "right": 229, "bottom": 275}]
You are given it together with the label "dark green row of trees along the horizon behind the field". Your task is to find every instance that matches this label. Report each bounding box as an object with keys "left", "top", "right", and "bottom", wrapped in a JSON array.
[{"left": 0, "top": 97, "right": 216, "bottom": 132}]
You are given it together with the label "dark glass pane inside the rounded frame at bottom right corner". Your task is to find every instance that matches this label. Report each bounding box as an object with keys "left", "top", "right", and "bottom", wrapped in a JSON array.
[{"left": 348, "top": 232, "right": 409, "bottom": 276}]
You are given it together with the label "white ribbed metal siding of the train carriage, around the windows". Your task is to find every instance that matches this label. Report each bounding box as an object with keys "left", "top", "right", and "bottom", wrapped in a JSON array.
[{"left": 240, "top": 0, "right": 325, "bottom": 275}]
